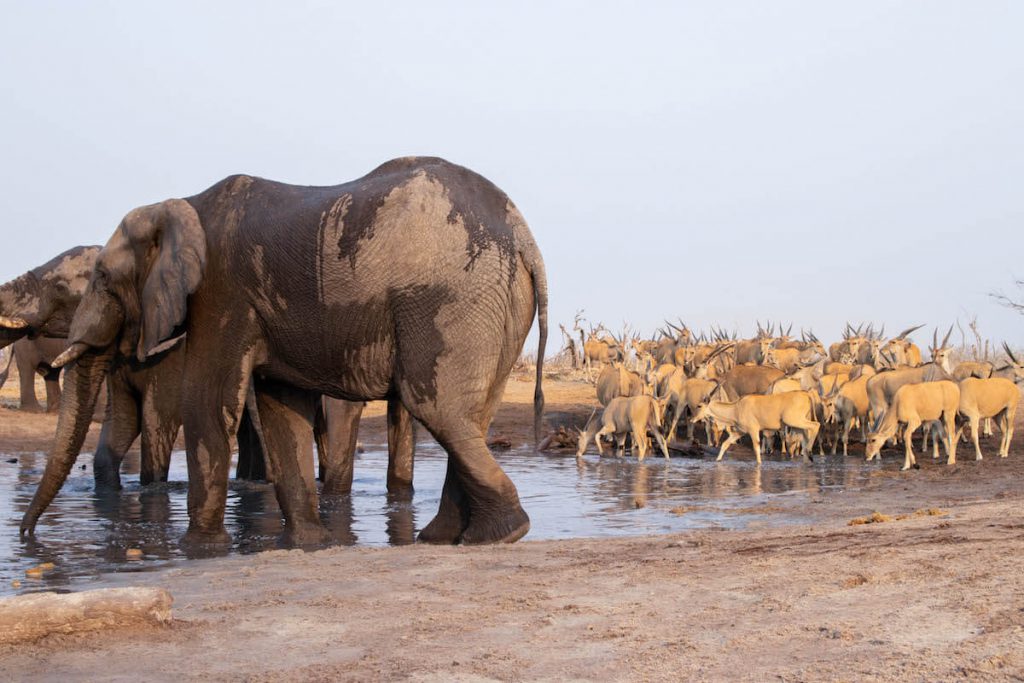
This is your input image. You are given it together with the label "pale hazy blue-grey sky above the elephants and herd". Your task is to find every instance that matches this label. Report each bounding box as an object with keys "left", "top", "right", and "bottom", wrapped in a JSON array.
[{"left": 0, "top": 0, "right": 1024, "bottom": 347}]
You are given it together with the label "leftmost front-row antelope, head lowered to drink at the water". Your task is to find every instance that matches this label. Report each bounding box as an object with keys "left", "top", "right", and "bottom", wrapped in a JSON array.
[{"left": 577, "top": 395, "right": 669, "bottom": 461}]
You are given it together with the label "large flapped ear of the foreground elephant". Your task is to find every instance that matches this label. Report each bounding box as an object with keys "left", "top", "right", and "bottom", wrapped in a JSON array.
[{"left": 137, "top": 200, "right": 206, "bottom": 360}]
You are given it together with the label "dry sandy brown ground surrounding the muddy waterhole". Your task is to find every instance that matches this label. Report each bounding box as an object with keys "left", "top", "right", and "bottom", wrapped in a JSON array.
[{"left": 0, "top": 370, "right": 1024, "bottom": 681}]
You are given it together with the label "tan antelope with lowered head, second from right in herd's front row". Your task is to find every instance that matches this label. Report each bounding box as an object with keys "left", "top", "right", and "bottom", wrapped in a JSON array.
[{"left": 864, "top": 373, "right": 959, "bottom": 470}]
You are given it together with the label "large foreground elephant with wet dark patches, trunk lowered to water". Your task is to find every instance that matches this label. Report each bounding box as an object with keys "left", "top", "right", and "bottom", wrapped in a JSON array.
[{"left": 20, "top": 158, "right": 548, "bottom": 546}]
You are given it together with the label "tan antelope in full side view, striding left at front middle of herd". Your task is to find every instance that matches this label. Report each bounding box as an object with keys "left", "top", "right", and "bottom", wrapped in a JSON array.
[{"left": 690, "top": 391, "right": 819, "bottom": 463}]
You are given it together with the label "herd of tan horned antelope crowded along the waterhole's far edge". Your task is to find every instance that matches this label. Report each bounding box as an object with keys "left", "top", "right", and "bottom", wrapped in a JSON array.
[{"left": 562, "top": 316, "right": 1024, "bottom": 470}]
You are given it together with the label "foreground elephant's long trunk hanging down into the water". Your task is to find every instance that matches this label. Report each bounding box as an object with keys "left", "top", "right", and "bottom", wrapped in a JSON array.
[{"left": 20, "top": 346, "right": 114, "bottom": 537}]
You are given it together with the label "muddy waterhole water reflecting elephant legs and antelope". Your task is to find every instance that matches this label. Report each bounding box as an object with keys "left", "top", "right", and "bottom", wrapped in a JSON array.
[{"left": 0, "top": 443, "right": 872, "bottom": 594}]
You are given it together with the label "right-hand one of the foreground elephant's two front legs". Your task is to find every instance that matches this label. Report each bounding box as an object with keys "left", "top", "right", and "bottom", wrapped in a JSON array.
[{"left": 255, "top": 379, "right": 328, "bottom": 545}]
